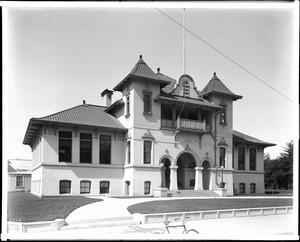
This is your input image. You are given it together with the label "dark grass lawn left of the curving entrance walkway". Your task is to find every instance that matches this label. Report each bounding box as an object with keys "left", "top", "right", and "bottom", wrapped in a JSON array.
[{"left": 7, "top": 192, "right": 103, "bottom": 222}]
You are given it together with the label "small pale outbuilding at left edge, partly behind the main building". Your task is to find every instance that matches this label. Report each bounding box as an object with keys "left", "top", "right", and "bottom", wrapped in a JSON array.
[{"left": 7, "top": 159, "right": 32, "bottom": 192}]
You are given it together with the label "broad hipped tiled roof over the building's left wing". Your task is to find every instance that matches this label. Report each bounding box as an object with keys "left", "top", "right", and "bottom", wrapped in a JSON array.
[{"left": 23, "top": 104, "right": 127, "bottom": 145}]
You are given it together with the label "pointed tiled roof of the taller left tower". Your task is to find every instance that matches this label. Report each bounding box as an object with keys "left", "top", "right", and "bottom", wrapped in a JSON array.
[{"left": 113, "top": 55, "right": 170, "bottom": 91}]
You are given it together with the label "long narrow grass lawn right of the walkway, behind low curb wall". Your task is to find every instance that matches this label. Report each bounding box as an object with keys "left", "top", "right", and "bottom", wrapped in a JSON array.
[{"left": 127, "top": 198, "right": 293, "bottom": 214}]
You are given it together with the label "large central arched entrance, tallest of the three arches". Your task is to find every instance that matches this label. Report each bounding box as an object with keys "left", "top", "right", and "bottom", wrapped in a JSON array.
[{"left": 177, "top": 153, "right": 196, "bottom": 190}]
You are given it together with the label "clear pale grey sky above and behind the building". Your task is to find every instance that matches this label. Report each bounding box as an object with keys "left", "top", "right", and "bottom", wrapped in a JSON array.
[{"left": 2, "top": 3, "right": 299, "bottom": 162}]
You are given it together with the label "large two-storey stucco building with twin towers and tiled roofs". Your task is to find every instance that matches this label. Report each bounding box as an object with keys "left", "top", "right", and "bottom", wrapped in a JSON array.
[{"left": 23, "top": 56, "right": 274, "bottom": 196}]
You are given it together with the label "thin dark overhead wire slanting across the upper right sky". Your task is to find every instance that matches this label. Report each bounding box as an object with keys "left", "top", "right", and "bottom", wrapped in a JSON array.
[{"left": 155, "top": 8, "right": 294, "bottom": 103}]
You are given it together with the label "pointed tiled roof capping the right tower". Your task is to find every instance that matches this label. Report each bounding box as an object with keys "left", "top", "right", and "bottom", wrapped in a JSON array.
[{"left": 201, "top": 72, "right": 242, "bottom": 101}]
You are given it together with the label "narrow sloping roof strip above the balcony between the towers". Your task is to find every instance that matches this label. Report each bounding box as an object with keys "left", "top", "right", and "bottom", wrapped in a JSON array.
[{"left": 154, "top": 93, "right": 221, "bottom": 109}]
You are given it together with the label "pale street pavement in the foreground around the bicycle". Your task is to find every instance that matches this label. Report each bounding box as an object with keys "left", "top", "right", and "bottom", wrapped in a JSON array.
[{"left": 10, "top": 214, "right": 299, "bottom": 240}]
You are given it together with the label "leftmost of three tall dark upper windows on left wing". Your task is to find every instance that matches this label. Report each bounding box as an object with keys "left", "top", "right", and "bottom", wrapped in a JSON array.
[{"left": 58, "top": 131, "right": 72, "bottom": 162}]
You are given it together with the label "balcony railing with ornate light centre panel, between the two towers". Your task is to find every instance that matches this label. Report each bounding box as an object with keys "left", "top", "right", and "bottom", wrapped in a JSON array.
[{"left": 161, "top": 118, "right": 211, "bottom": 133}]
